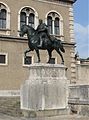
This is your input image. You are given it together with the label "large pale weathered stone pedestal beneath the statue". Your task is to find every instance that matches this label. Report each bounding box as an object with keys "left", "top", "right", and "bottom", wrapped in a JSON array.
[{"left": 21, "top": 63, "right": 68, "bottom": 117}]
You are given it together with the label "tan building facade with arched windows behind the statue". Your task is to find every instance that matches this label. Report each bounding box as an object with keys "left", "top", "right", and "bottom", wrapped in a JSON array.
[{"left": 0, "top": 0, "right": 76, "bottom": 90}]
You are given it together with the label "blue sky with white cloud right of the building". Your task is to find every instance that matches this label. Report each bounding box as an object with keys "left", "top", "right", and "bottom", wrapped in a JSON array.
[{"left": 74, "top": 0, "right": 89, "bottom": 59}]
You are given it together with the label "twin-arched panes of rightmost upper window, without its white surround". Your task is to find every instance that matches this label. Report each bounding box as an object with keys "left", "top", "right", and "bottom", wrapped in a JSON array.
[{"left": 47, "top": 12, "right": 60, "bottom": 35}]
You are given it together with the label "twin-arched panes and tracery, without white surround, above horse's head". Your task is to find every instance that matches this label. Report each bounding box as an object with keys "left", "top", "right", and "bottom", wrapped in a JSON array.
[{"left": 20, "top": 7, "right": 35, "bottom": 27}]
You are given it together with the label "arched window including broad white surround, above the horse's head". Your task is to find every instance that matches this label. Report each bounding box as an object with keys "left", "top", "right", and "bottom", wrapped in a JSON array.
[{"left": 18, "top": 6, "right": 39, "bottom": 32}]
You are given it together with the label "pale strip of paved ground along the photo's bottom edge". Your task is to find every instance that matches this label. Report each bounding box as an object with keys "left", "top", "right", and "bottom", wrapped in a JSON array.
[{"left": 0, "top": 113, "right": 89, "bottom": 120}]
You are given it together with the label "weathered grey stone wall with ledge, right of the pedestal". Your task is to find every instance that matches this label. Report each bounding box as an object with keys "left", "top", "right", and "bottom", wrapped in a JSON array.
[{"left": 68, "top": 85, "right": 89, "bottom": 116}]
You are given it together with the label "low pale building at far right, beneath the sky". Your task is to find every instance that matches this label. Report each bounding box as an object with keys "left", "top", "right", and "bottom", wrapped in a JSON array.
[{"left": 76, "top": 58, "right": 89, "bottom": 85}]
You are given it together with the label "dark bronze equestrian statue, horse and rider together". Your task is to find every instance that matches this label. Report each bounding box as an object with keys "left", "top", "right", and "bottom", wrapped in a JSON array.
[{"left": 19, "top": 20, "right": 65, "bottom": 64}]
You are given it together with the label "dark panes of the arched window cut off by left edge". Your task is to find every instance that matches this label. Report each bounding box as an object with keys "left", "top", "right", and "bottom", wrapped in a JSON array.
[{"left": 0, "top": 6, "right": 6, "bottom": 28}]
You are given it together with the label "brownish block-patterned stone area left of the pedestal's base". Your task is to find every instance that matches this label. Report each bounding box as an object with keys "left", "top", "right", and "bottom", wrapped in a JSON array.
[{"left": 0, "top": 97, "right": 23, "bottom": 117}]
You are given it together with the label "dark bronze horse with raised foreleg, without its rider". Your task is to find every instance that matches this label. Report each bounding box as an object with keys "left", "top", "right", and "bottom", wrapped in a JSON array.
[{"left": 19, "top": 25, "right": 65, "bottom": 64}]
